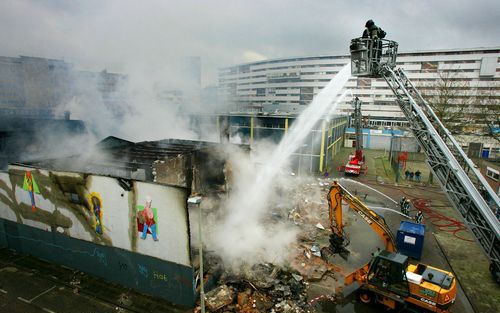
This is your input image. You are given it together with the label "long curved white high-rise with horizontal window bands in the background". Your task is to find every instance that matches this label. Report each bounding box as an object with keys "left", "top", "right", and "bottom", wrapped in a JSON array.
[{"left": 219, "top": 47, "right": 500, "bottom": 155}]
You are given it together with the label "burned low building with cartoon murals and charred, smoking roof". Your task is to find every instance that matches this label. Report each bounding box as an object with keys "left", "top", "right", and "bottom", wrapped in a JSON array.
[{"left": 0, "top": 137, "right": 242, "bottom": 306}]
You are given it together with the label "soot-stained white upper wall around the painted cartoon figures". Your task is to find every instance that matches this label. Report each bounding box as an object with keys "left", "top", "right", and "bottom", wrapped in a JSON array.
[{"left": 0, "top": 166, "right": 190, "bottom": 266}]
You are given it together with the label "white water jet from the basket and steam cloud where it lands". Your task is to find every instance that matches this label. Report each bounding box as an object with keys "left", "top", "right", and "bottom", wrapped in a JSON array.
[{"left": 210, "top": 64, "right": 351, "bottom": 267}]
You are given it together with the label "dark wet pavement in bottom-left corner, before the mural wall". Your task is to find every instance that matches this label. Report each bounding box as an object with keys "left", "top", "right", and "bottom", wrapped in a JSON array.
[{"left": 0, "top": 249, "right": 190, "bottom": 313}]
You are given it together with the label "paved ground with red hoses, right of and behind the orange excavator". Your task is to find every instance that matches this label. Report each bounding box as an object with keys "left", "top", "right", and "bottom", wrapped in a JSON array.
[{"left": 330, "top": 149, "right": 500, "bottom": 312}]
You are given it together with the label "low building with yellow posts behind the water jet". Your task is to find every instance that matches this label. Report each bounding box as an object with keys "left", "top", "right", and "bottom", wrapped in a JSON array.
[{"left": 190, "top": 113, "right": 349, "bottom": 174}]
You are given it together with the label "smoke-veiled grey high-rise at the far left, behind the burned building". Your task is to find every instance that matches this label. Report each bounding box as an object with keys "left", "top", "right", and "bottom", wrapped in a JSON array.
[{"left": 0, "top": 56, "right": 126, "bottom": 118}]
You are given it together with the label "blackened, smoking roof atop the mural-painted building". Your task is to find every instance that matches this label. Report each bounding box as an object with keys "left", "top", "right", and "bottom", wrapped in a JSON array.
[{"left": 20, "top": 136, "right": 249, "bottom": 191}]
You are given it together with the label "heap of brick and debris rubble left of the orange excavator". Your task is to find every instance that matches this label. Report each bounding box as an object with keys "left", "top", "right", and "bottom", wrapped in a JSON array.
[{"left": 195, "top": 180, "right": 352, "bottom": 313}]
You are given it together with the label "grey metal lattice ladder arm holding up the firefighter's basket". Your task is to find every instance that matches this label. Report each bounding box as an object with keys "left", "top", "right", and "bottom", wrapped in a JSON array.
[{"left": 381, "top": 66, "right": 500, "bottom": 268}]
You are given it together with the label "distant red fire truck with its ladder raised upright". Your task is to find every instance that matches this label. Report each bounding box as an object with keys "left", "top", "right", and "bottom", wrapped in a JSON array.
[{"left": 344, "top": 97, "right": 365, "bottom": 176}]
